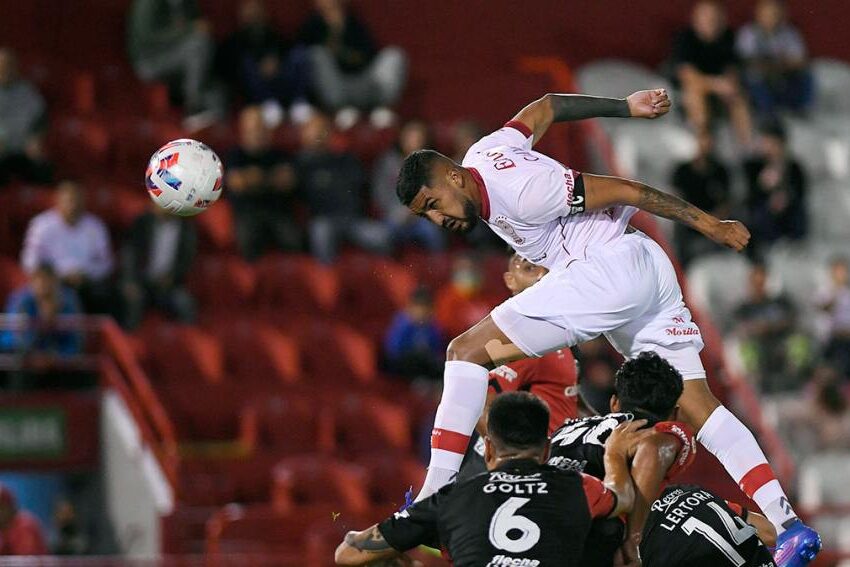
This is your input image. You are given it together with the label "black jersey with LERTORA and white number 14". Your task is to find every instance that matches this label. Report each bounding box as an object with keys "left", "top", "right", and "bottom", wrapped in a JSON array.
[{"left": 640, "top": 485, "right": 776, "bottom": 567}]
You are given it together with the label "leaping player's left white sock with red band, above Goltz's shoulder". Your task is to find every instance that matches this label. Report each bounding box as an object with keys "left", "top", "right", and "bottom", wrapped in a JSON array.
[{"left": 416, "top": 360, "right": 488, "bottom": 502}]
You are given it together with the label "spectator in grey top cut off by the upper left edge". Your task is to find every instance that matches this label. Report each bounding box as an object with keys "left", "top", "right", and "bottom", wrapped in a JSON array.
[{"left": 0, "top": 48, "right": 53, "bottom": 186}]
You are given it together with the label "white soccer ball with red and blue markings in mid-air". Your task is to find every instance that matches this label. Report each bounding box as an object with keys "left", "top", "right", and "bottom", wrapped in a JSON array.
[{"left": 145, "top": 138, "right": 224, "bottom": 217}]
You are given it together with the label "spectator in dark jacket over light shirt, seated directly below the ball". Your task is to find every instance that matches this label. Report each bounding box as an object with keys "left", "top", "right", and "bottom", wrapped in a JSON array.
[{"left": 121, "top": 203, "right": 198, "bottom": 329}]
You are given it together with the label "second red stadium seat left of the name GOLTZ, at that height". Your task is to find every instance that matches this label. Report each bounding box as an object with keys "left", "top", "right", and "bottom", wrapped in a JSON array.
[{"left": 272, "top": 457, "right": 369, "bottom": 514}]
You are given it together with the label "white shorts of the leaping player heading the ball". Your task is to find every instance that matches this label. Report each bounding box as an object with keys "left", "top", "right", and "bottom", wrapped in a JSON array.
[{"left": 491, "top": 231, "right": 705, "bottom": 380}]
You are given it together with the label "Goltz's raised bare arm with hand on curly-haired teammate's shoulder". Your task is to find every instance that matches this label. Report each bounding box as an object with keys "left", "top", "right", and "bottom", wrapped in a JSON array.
[{"left": 602, "top": 419, "right": 653, "bottom": 518}]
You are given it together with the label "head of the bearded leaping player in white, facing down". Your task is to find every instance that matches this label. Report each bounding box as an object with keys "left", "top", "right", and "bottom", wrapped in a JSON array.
[{"left": 396, "top": 150, "right": 479, "bottom": 233}]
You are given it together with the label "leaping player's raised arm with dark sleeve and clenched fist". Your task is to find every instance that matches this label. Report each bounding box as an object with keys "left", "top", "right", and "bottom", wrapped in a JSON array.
[{"left": 513, "top": 89, "right": 670, "bottom": 144}]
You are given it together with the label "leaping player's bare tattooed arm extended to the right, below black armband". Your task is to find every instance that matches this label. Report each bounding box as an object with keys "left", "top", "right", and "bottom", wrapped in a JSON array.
[{"left": 582, "top": 173, "right": 750, "bottom": 252}]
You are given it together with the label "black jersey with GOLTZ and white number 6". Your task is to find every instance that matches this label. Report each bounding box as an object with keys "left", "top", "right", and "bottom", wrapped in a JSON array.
[{"left": 379, "top": 460, "right": 616, "bottom": 567}]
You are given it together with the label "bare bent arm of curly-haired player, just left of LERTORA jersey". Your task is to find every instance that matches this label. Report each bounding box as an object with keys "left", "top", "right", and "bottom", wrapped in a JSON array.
[{"left": 627, "top": 433, "right": 679, "bottom": 545}]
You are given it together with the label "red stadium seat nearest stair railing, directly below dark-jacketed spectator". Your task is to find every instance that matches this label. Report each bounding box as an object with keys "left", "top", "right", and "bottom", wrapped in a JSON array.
[{"left": 140, "top": 323, "right": 224, "bottom": 384}]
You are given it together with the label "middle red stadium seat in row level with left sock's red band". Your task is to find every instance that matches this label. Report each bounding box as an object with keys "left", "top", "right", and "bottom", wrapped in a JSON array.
[{"left": 240, "top": 393, "right": 334, "bottom": 456}]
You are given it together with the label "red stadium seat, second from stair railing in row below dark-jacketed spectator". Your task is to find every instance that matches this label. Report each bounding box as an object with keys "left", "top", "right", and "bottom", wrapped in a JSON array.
[{"left": 213, "top": 319, "right": 303, "bottom": 391}]
